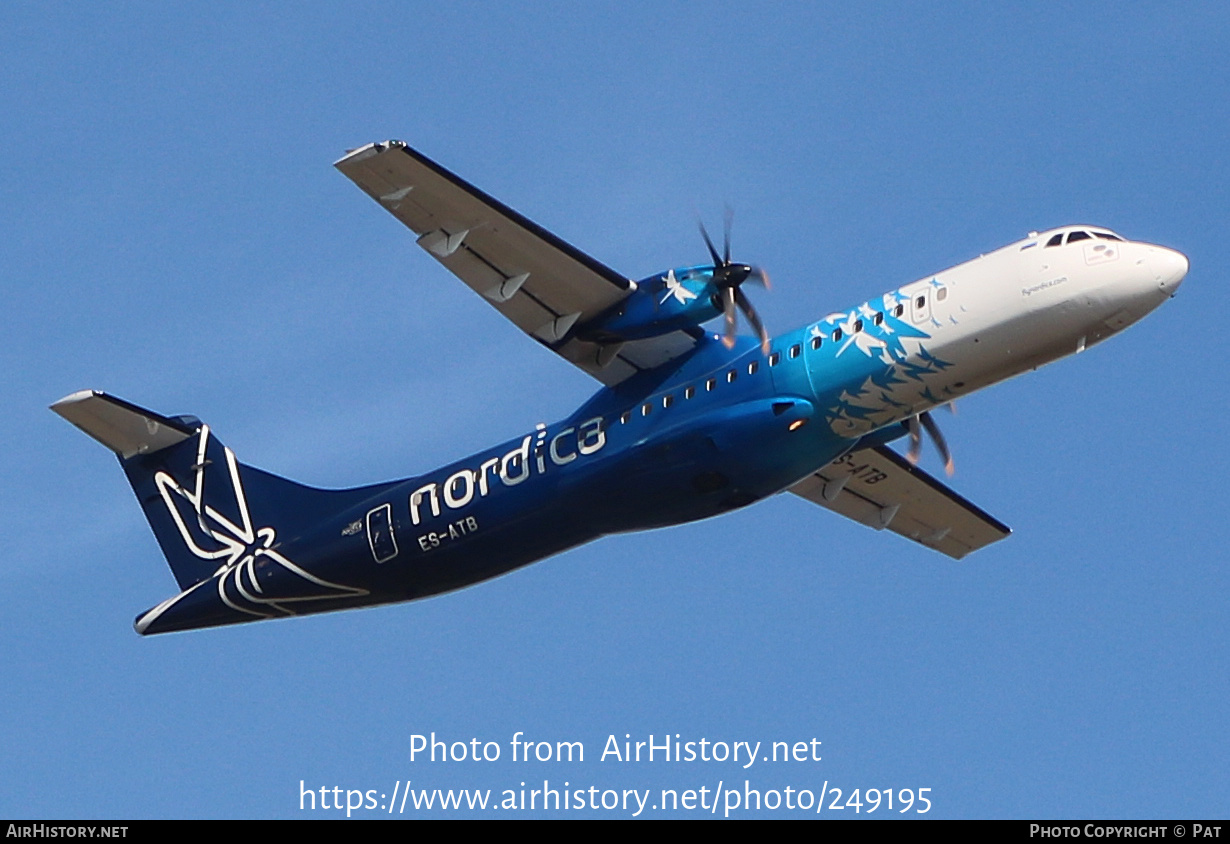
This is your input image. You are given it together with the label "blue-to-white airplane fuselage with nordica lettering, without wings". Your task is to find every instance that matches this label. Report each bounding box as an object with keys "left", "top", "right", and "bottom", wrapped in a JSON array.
[{"left": 105, "top": 226, "right": 1187, "bottom": 632}]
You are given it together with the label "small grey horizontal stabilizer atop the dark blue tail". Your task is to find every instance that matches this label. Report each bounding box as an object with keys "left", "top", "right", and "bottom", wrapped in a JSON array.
[{"left": 52, "top": 390, "right": 196, "bottom": 459}]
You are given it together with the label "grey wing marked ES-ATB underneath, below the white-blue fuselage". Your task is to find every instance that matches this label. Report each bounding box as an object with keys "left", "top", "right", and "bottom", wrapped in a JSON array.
[{"left": 790, "top": 445, "right": 1012, "bottom": 560}]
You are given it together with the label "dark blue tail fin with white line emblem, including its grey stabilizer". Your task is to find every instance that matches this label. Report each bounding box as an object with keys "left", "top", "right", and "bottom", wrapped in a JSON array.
[{"left": 52, "top": 390, "right": 386, "bottom": 591}]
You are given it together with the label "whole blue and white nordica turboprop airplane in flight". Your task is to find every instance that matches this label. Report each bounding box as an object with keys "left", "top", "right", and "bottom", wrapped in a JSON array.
[{"left": 52, "top": 140, "right": 1188, "bottom": 635}]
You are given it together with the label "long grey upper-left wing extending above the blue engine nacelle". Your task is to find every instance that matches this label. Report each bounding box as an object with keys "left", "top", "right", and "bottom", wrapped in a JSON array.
[{"left": 333, "top": 140, "right": 702, "bottom": 386}]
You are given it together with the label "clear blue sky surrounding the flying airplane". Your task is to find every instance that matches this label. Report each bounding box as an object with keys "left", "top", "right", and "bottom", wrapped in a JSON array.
[{"left": 0, "top": 2, "right": 1230, "bottom": 818}]
